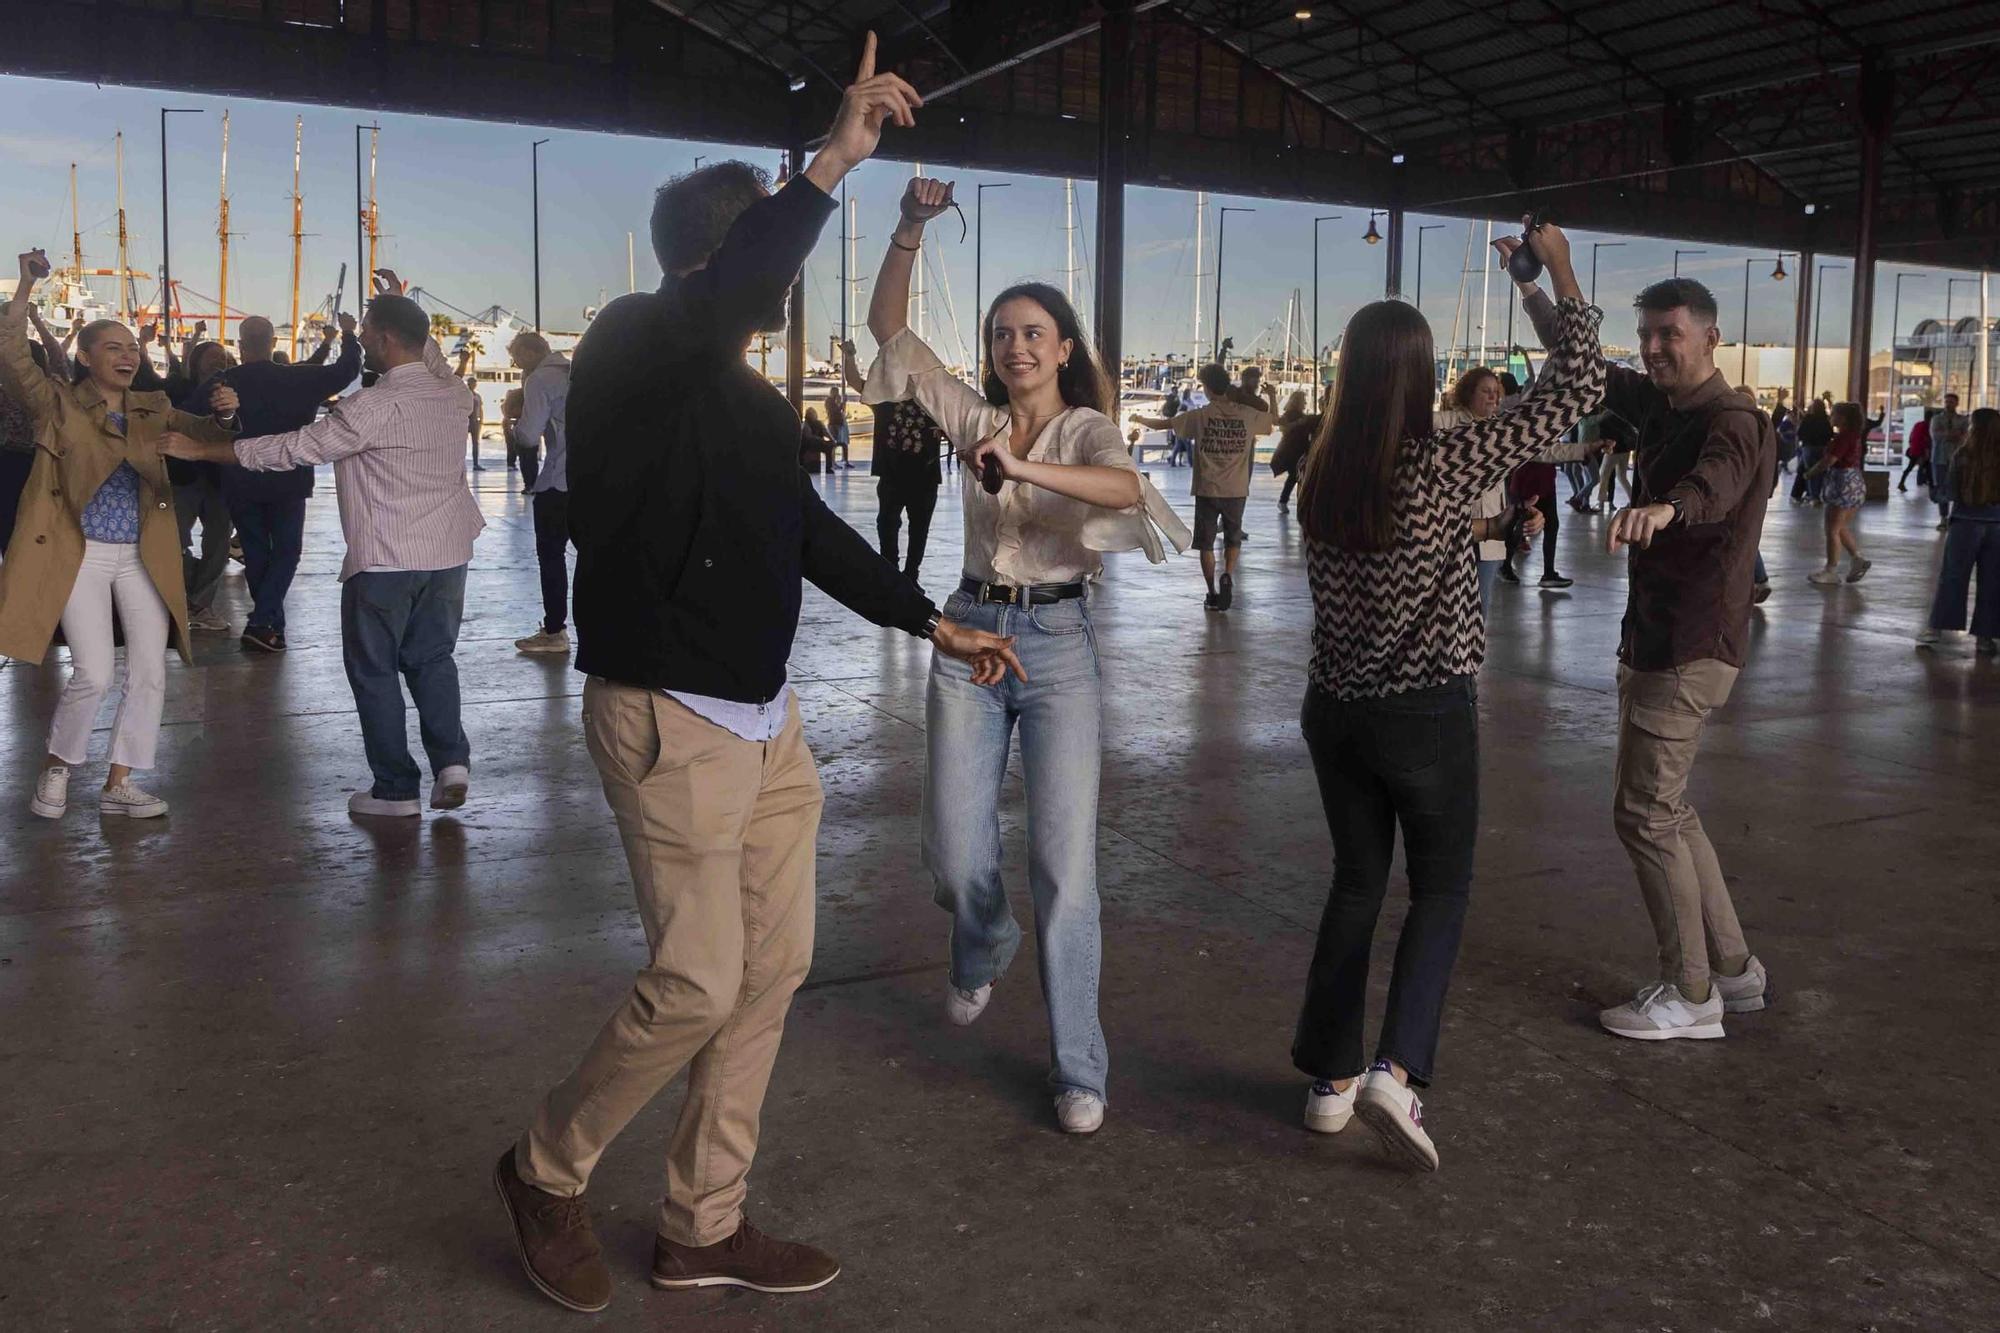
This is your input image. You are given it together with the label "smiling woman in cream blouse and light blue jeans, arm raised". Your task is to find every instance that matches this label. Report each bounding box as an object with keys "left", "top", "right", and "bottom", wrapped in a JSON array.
[{"left": 862, "top": 180, "right": 1188, "bottom": 1133}]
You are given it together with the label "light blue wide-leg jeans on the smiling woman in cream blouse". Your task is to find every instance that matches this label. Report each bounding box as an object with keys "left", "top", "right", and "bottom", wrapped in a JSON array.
[{"left": 924, "top": 592, "right": 1110, "bottom": 1097}]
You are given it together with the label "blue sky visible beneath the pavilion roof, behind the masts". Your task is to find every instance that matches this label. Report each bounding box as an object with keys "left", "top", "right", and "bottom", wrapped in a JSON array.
[{"left": 0, "top": 78, "right": 1978, "bottom": 368}]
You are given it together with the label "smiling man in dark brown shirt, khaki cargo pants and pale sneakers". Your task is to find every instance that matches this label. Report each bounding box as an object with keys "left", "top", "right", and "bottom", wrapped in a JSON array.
[{"left": 1526, "top": 264, "right": 1778, "bottom": 1041}]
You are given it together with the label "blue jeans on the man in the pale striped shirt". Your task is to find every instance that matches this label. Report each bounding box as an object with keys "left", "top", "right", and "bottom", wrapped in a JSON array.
[{"left": 340, "top": 564, "right": 472, "bottom": 801}]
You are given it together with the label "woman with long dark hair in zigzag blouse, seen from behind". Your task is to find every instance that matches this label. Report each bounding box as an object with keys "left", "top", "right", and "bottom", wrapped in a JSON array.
[{"left": 1292, "top": 226, "right": 1604, "bottom": 1171}]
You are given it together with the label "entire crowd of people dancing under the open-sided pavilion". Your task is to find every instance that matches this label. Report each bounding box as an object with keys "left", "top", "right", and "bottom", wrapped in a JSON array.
[{"left": 0, "top": 28, "right": 2000, "bottom": 1311}]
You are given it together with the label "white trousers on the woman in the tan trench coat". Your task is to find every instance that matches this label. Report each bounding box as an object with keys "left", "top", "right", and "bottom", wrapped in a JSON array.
[{"left": 48, "top": 540, "right": 168, "bottom": 769}]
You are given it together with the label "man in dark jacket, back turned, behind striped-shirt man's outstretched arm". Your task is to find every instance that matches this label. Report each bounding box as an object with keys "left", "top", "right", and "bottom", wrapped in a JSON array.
[{"left": 196, "top": 314, "right": 362, "bottom": 652}]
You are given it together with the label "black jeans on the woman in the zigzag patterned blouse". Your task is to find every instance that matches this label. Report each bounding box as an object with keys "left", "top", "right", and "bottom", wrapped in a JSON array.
[{"left": 1292, "top": 677, "right": 1480, "bottom": 1087}]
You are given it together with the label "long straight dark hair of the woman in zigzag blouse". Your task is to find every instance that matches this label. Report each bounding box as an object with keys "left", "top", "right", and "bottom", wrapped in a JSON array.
[{"left": 1298, "top": 300, "right": 1438, "bottom": 550}]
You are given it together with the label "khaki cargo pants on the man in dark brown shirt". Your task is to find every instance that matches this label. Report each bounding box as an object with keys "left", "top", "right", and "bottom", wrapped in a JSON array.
[{"left": 1612, "top": 658, "right": 1750, "bottom": 1001}]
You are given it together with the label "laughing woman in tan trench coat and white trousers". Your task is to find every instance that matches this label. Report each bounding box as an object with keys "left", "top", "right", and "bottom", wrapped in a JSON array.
[{"left": 0, "top": 250, "right": 236, "bottom": 819}]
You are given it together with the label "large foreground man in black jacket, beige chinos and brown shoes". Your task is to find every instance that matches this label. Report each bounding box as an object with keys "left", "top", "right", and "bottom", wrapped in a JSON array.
[{"left": 494, "top": 36, "right": 1020, "bottom": 1311}]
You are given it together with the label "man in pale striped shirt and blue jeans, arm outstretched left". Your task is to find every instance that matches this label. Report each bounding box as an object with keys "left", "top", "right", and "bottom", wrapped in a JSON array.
[{"left": 162, "top": 286, "right": 486, "bottom": 817}]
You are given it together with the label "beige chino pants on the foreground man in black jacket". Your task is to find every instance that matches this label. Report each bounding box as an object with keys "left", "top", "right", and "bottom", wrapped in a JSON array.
[{"left": 514, "top": 677, "right": 822, "bottom": 1245}]
